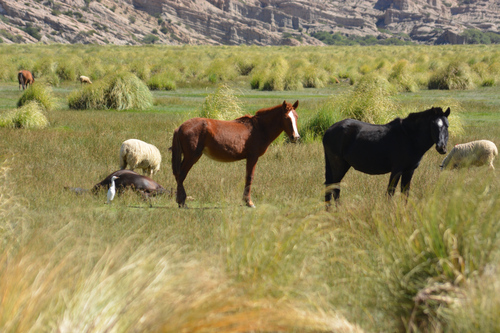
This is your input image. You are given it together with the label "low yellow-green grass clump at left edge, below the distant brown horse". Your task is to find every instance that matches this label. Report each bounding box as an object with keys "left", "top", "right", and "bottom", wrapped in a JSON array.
[{"left": 0, "top": 101, "right": 49, "bottom": 129}]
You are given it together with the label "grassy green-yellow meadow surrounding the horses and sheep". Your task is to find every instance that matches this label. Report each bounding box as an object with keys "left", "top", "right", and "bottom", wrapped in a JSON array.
[{"left": 0, "top": 45, "right": 500, "bottom": 332}]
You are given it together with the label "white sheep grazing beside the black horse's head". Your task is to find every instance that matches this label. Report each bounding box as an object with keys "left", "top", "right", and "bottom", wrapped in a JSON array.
[{"left": 441, "top": 140, "right": 498, "bottom": 170}]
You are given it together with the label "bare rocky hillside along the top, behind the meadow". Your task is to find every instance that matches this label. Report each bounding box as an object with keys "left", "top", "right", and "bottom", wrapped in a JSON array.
[{"left": 0, "top": 0, "right": 500, "bottom": 45}]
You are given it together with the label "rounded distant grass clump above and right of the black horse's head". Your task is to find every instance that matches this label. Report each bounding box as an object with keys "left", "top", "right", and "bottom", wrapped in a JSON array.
[{"left": 428, "top": 61, "right": 474, "bottom": 90}]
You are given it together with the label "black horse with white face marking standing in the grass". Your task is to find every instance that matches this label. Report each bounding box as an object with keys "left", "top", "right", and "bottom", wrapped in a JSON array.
[{"left": 323, "top": 107, "right": 450, "bottom": 206}]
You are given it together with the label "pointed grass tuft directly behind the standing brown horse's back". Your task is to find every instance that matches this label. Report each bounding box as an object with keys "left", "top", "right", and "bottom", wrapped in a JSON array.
[{"left": 200, "top": 84, "right": 243, "bottom": 120}]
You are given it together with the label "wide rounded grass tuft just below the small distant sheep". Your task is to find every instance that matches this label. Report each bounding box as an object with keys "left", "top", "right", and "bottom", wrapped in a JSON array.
[{"left": 68, "top": 73, "right": 153, "bottom": 110}]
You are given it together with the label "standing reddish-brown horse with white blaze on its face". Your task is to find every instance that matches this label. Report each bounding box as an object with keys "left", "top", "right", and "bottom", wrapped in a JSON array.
[{"left": 172, "top": 101, "right": 300, "bottom": 207}]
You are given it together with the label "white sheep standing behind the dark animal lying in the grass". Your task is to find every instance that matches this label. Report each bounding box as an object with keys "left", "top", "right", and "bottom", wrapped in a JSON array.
[{"left": 120, "top": 139, "right": 161, "bottom": 177}]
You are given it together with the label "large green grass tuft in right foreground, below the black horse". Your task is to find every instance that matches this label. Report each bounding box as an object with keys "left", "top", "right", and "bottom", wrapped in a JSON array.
[{"left": 328, "top": 170, "right": 500, "bottom": 332}]
